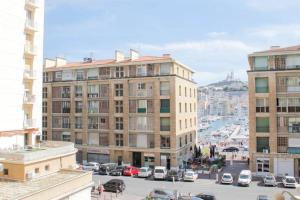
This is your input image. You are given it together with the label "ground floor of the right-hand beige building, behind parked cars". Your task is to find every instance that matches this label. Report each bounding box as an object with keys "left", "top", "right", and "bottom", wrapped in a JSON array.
[{"left": 250, "top": 154, "right": 300, "bottom": 177}]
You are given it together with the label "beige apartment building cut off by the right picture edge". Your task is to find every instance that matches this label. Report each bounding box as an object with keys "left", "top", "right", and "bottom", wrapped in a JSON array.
[{"left": 248, "top": 45, "right": 300, "bottom": 176}]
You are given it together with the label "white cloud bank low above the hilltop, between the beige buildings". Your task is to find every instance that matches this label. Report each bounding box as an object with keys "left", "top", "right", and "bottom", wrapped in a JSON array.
[{"left": 130, "top": 39, "right": 258, "bottom": 85}]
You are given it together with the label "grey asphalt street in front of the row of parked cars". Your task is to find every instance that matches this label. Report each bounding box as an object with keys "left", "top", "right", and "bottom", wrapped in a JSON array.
[{"left": 93, "top": 175, "right": 296, "bottom": 200}]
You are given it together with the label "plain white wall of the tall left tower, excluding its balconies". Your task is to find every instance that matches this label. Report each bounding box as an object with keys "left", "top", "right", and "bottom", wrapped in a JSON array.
[{"left": 0, "top": 0, "right": 44, "bottom": 146}]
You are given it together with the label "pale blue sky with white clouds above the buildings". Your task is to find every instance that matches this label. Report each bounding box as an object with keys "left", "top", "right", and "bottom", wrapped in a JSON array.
[{"left": 44, "top": 0, "right": 300, "bottom": 85}]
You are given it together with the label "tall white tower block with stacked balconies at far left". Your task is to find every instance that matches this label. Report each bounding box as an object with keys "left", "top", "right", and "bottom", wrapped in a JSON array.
[{"left": 0, "top": 0, "right": 44, "bottom": 149}]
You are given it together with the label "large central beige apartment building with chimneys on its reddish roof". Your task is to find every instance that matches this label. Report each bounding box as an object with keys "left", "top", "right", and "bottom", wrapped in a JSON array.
[{"left": 43, "top": 50, "right": 197, "bottom": 167}]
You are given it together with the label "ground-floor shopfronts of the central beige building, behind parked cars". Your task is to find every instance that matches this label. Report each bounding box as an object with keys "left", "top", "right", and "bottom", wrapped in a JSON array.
[{"left": 76, "top": 146, "right": 193, "bottom": 169}]
